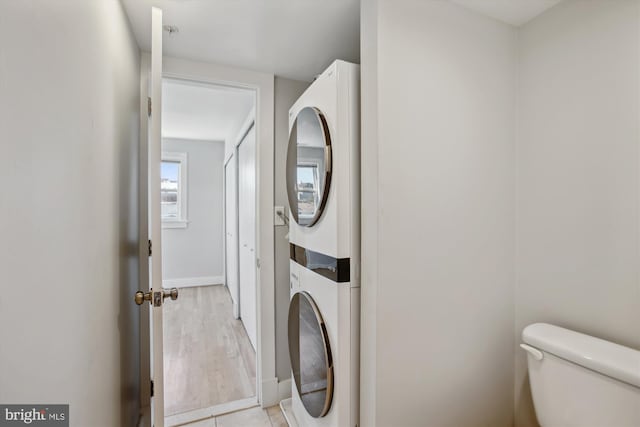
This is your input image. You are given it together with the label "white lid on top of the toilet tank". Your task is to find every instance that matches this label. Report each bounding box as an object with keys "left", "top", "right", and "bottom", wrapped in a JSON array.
[{"left": 522, "top": 323, "right": 640, "bottom": 387}]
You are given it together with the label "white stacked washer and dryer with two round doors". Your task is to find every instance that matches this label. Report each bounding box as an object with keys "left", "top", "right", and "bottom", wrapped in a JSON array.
[{"left": 287, "top": 61, "right": 360, "bottom": 427}]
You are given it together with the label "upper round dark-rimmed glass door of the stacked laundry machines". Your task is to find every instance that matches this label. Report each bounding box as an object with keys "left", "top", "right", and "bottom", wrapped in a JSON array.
[{"left": 287, "top": 107, "right": 331, "bottom": 227}]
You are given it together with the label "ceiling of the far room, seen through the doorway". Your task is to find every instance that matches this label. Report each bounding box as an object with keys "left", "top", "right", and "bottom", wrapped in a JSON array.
[{"left": 162, "top": 79, "right": 255, "bottom": 141}]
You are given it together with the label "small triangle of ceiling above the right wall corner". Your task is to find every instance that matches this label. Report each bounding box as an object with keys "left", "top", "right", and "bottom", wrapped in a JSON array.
[{"left": 450, "top": 0, "right": 562, "bottom": 27}]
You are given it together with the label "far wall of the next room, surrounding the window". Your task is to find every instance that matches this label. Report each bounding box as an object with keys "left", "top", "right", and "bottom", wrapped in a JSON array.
[{"left": 162, "top": 138, "right": 224, "bottom": 286}]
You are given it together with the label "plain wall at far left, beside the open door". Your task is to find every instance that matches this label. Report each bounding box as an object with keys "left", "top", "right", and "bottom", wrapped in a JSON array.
[{"left": 0, "top": 0, "right": 139, "bottom": 427}]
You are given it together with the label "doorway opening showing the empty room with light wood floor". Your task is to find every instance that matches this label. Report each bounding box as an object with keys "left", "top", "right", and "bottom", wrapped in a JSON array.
[{"left": 160, "top": 78, "right": 258, "bottom": 426}]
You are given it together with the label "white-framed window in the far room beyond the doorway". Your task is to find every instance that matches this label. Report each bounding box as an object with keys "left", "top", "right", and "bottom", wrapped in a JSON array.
[{"left": 160, "top": 153, "right": 187, "bottom": 228}]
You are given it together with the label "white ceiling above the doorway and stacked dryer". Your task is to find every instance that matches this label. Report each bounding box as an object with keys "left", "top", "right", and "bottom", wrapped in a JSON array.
[{"left": 122, "top": 0, "right": 360, "bottom": 81}]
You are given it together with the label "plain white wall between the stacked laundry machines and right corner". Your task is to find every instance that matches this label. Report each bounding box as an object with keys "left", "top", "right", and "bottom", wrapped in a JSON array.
[{"left": 361, "top": 0, "right": 517, "bottom": 427}]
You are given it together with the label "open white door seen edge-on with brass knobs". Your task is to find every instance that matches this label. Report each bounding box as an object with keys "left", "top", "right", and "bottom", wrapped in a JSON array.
[{"left": 135, "top": 7, "right": 178, "bottom": 427}]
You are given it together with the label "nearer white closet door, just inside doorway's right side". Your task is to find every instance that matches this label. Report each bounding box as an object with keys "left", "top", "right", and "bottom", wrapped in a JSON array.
[{"left": 238, "top": 127, "right": 257, "bottom": 349}]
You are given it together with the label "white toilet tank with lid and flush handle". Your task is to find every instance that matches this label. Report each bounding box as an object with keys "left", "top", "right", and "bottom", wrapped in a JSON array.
[{"left": 521, "top": 323, "right": 640, "bottom": 427}]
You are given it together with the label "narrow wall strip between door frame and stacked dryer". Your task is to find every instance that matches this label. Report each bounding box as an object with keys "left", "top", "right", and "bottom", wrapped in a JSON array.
[{"left": 274, "top": 75, "right": 308, "bottom": 381}]
